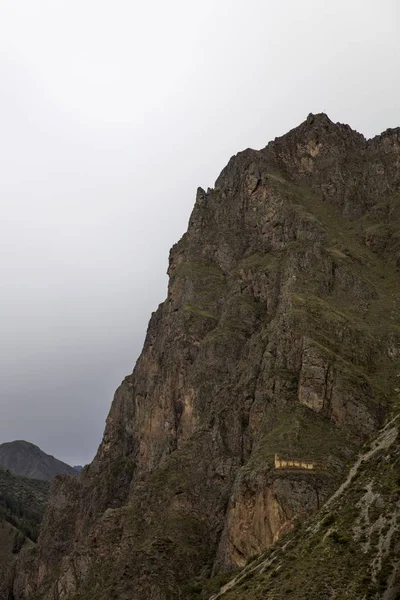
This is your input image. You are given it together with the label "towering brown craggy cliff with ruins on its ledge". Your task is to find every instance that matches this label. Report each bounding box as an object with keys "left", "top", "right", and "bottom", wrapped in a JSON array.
[{"left": 13, "top": 115, "right": 400, "bottom": 600}]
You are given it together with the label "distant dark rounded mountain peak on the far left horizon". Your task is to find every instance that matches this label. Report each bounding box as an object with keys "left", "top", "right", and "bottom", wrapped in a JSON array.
[{"left": 0, "top": 440, "right": 76, "bottom": 481}]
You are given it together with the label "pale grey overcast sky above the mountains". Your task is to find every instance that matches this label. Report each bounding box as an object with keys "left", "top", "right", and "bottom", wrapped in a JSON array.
[{"left": 0, "top": 0, "right": 400, "bottom": 464}]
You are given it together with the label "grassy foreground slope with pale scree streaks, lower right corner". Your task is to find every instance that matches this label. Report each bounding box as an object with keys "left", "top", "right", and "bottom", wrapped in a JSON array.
[{"left": 209, "top": 417, "right": 400, "bottom": 600}]
